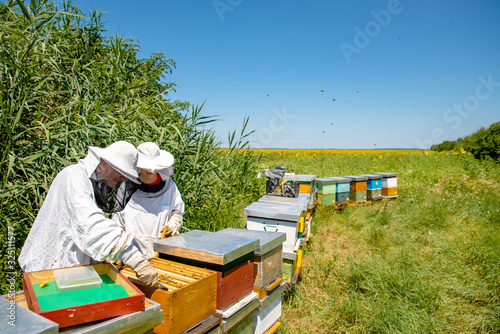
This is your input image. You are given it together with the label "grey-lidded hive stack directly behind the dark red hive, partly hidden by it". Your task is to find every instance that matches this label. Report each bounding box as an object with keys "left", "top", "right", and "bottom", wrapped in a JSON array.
[{"left": 216, "top": 228, "right": 286, "bottom": 333}]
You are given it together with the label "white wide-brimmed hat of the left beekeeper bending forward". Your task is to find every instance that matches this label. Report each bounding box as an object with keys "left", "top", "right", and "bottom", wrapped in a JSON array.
[{"left": 89, "top": 141, "right": 141, "bottom": 184}]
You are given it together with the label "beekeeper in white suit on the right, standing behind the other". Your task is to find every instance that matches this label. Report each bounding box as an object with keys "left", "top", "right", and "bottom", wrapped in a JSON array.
[{"left": 112, "top": 142, "right": 184, "bottom": 258}]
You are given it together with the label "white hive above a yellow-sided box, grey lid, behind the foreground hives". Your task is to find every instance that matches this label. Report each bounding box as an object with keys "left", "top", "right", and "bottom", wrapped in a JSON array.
[{"left": 244, "top": 202, "right": 306, "bottom": 283}]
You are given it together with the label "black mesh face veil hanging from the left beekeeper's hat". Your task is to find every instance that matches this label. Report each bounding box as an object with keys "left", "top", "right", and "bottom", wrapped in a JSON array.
[{"left": 91, "top": 178, "right": 138, "bottom": 213}]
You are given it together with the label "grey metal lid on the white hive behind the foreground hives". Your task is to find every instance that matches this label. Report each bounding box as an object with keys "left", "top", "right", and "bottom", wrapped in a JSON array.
[{"left": 243, "top": 202, "right": 303, "bottom": 223}]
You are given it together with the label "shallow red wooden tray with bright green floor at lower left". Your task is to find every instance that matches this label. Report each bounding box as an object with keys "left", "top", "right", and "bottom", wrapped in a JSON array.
[{"left": 23, "top": 263, "right": 145, "bottom": 328}]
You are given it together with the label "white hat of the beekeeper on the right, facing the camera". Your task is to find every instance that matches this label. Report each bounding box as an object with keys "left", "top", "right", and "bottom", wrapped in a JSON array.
[{"left": 137, "top": 142, "right": 174, "bottom": 179}]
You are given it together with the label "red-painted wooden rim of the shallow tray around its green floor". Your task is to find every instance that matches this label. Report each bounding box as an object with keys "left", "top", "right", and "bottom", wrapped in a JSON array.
[{"left": 23, "top": 263, "right": 145, "bottom": 328}]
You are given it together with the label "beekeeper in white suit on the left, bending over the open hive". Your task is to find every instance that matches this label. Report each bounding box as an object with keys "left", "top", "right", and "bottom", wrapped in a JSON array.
[{"left": 18, "top": 141, "right": 158, "bottom": 285}]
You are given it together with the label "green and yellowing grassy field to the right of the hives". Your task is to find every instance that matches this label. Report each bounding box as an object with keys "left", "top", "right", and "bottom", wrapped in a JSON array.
[{"left": 254, "top": 150, "right": 500, "bottom": 333}]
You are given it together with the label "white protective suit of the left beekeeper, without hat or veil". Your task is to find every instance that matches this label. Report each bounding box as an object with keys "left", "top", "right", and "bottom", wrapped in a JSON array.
[{"left": 18, "top": 145, "right": 140, "bottom": 272}]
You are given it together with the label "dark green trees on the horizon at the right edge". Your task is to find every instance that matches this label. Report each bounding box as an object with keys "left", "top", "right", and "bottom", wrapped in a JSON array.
[{"left": 431, "top": 122, "right": 500, "bottom": 161}]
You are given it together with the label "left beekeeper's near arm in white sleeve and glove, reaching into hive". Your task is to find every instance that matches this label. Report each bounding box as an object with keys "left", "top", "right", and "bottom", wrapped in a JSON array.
[{"left": 66, "top": 175, "right": 158, "bottom": 284}]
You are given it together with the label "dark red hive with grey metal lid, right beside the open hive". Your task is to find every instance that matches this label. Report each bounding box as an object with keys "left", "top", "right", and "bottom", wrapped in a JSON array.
[{"left": 153, "top": 230, "right": 260, "bottom": 333}]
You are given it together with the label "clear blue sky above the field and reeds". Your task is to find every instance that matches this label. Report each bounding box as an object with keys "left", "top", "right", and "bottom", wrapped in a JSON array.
[{"left": 73, "top": 0, "right": 500, "bottom": 148}]
